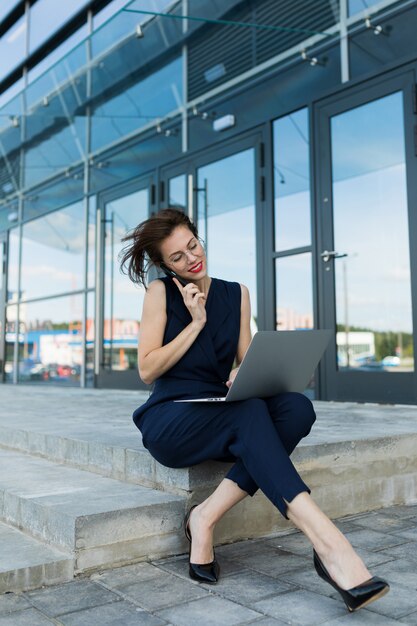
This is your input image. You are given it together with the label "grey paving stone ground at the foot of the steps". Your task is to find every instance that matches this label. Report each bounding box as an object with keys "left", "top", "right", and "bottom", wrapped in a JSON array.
[{"left": 0, "top": 504, "right": 417, "bottom": 626}]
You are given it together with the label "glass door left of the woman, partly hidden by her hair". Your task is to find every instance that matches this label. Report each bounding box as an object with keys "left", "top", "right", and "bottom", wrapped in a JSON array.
[{"left": 97, "top": 178, "right": 153, "bottom": 389}]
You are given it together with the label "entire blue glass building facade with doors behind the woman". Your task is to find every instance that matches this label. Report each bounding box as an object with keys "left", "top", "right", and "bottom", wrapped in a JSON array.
[{"left": 0, "top": 0, "right": 417, "bottom": 403}]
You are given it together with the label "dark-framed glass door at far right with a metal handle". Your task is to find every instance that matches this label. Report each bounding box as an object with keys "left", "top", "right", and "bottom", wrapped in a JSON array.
[{"left": 316, "top": 72, "right": 417, "bottom": 402}]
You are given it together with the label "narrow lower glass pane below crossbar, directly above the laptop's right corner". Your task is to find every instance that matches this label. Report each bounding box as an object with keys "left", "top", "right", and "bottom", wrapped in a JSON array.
[{"left": 275, "top": 253, "right": 314, "bottom": 330}]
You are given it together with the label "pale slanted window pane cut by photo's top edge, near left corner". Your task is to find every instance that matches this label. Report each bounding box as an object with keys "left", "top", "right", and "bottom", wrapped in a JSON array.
[{"left": 29, "top": 0, "right": 88, "bottom": 52}]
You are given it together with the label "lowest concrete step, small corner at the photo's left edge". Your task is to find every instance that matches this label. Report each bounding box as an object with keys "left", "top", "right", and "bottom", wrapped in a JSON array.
[{"left": 0, "top": 523, "right": 74, "bottom": 594}]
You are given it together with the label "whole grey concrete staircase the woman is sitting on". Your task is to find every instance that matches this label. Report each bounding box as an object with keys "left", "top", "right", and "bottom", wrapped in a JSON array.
[{"left": 0, "top": 385, "right": 417, "bottom": 593}]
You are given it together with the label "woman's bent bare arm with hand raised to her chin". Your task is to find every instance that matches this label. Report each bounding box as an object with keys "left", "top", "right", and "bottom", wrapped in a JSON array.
[{"left": 138, "top": 279, "right": 206, "bottom": 385}]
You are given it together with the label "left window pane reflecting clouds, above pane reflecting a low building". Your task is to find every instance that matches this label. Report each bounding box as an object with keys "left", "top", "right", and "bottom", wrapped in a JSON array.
[{"left": 21, "top": 202, "right": 85, "bottom": 299}]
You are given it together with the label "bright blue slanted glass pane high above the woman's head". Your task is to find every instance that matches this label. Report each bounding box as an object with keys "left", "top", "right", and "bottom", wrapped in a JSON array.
[{"left": 91, "top": 58, "right": 183, "bottom": 151}]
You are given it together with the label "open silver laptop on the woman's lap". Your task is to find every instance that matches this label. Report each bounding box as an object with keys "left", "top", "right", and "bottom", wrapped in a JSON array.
[{"left": 175, "top": 330, "right": 333, "bottom": 402}]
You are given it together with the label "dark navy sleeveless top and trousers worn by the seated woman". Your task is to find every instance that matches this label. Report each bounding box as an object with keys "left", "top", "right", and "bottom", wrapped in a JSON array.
[{"left": 133, "top": 278, "right": 315, "bottom": 517}]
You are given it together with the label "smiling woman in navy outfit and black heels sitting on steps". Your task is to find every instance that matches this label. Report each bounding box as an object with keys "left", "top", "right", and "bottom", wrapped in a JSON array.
[{"left": 118, "top": 209, "right": 389, "bottom": 611}]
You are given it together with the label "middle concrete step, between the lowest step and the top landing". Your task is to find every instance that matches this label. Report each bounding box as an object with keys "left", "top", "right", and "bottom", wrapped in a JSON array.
[{"left": 0, "top": 450, "right": 186, "bottom": 573}]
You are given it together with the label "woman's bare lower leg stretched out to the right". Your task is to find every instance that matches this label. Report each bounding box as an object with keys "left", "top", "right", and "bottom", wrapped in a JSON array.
[{"left": 287, "top": 492, "right": 371, "bottom": 589}]
